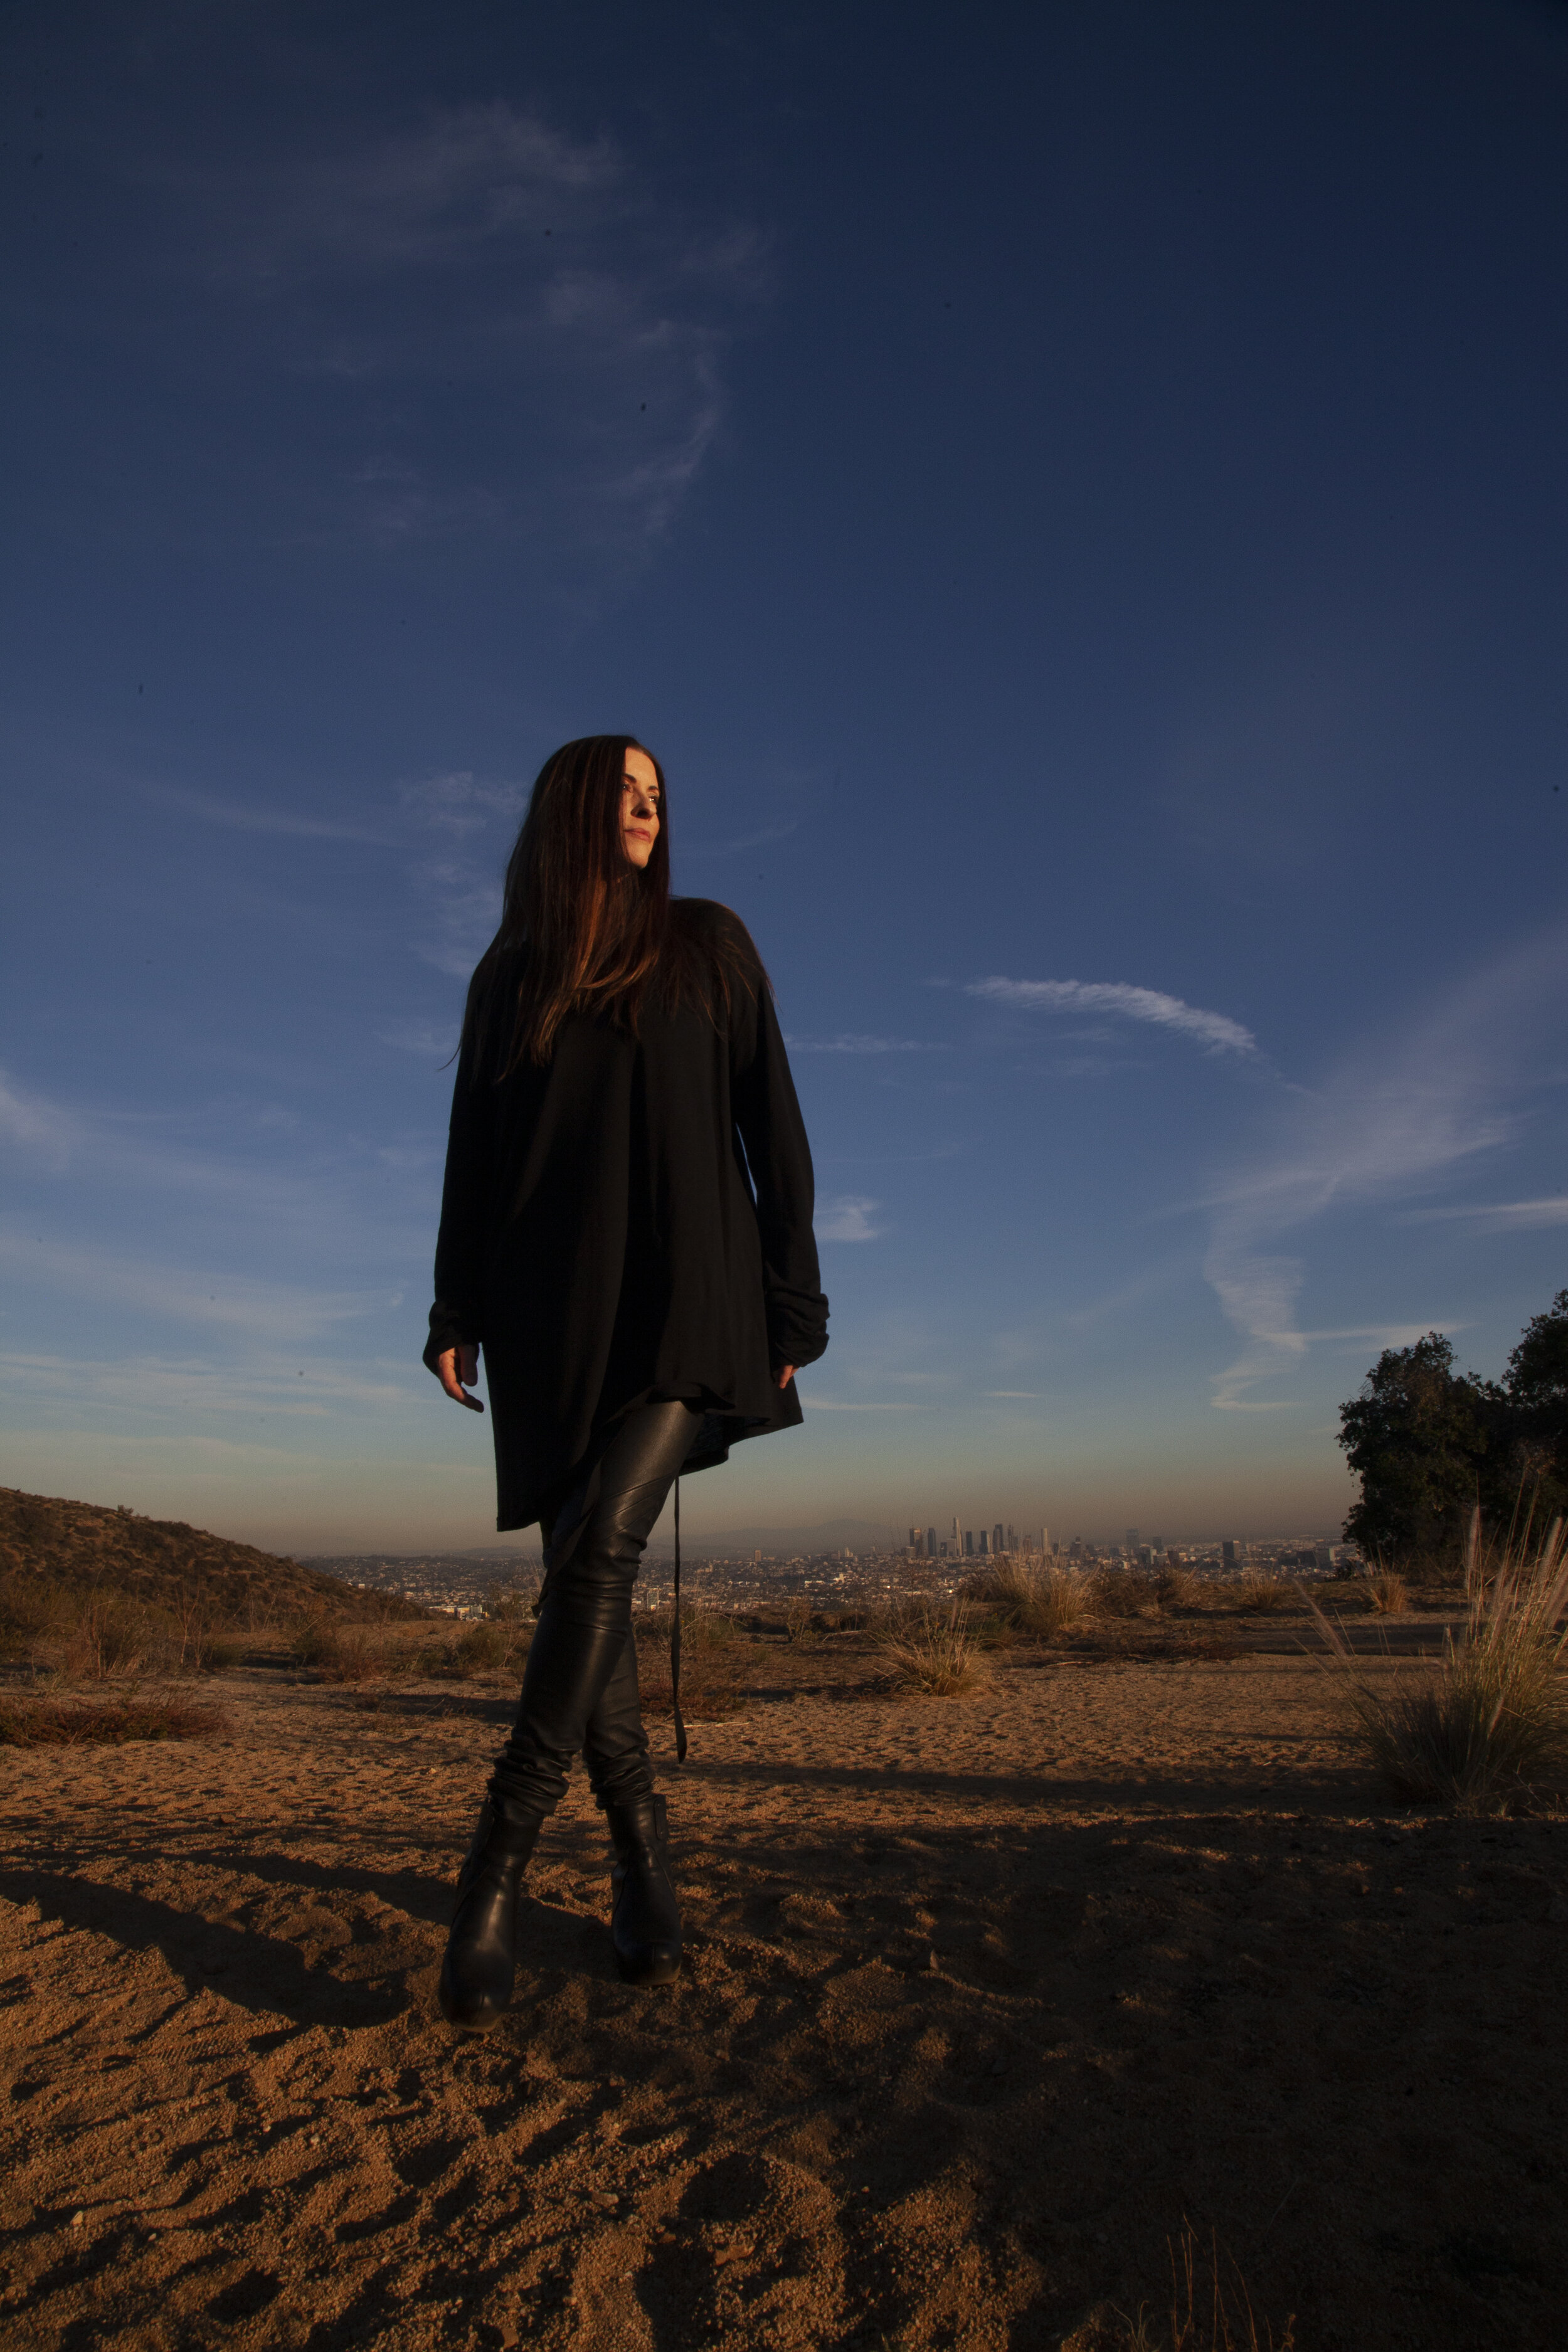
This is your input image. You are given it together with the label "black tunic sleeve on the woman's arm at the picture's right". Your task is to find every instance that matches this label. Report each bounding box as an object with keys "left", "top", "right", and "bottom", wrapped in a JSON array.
[{"left": 731, "top": 941, "right": 827, "bottom": 1367}]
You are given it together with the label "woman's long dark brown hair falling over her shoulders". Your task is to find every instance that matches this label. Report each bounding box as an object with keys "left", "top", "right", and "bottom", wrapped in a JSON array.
[{"left": 463, "top": 734, "right": 741, "bottom": 1078}]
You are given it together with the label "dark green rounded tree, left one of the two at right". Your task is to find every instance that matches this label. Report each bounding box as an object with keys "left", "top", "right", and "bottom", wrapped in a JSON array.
[{"left": 1340, "top": 1332, "right": 1498, "bottom": 1562}]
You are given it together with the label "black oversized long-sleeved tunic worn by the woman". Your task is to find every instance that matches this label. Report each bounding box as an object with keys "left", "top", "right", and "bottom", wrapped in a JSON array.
[{"left": 425, "top": 899, "right": 827, "bottom": 1529}]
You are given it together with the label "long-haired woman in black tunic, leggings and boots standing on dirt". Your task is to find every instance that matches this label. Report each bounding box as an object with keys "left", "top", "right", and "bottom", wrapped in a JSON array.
[{"left": 425, "top": 736, "right": 827, "bottom": 2030}]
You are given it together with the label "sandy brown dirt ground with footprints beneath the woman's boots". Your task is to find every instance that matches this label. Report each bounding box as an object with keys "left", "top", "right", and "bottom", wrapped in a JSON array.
[{"left": 0, "top": 1637, "right": 1568, "bottom": 2352}]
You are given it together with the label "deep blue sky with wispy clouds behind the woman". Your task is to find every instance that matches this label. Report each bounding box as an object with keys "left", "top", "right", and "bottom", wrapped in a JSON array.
[{"left": 0, "top": 0, "right": 1568, "bottom": 1550}]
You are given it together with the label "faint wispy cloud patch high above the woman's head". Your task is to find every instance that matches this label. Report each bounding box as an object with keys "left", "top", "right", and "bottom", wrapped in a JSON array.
[{"left": 176, "top": 101, "right": 766, "bottom": 569}]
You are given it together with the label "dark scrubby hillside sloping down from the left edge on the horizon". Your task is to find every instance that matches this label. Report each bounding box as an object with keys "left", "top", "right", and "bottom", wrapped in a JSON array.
[{"left": 0, "top": 1486, "right": 428, "bottom": 1623}]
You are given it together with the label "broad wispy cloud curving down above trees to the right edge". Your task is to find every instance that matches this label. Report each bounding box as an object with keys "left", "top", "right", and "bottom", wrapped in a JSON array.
[{"left": 1204, "top": 929, "right": 1568, "bottom": 1411}]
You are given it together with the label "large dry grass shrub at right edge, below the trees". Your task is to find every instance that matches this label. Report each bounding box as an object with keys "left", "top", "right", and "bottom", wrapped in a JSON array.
[{"left": 1314, "top": 1510, "right": 1568, "bottom": 1816}]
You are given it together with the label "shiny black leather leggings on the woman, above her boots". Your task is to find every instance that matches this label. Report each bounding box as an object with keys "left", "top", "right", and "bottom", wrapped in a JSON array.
[{"left": 491, "top": 1402, "right": 701, "bottom": 1813}]
